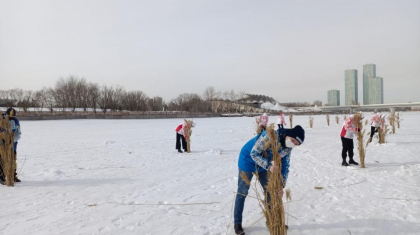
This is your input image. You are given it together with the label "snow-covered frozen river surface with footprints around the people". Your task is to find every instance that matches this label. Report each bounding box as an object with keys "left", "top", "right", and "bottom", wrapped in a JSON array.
[{"left": 0, "top": 113, "right": 420, "bottom": 235}]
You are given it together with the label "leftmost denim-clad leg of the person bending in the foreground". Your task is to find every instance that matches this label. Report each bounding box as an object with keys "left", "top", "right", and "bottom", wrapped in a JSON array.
[{"left": 233, "top": 170, "right": 252, "bottom": 224}]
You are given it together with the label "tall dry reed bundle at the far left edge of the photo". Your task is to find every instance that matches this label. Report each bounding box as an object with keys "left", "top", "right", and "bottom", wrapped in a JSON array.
[{"left": 0, "top": 115, "right": 16, "bottom": 186}]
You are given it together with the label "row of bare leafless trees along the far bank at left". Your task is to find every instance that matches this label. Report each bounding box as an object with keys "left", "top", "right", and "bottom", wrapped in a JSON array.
[{"left": 0, "top": 76, "right": 245, "bottom": 113}]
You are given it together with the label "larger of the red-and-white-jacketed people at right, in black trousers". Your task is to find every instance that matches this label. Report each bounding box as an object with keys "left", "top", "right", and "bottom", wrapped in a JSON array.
[{"left": 340, "top": 112, "right": 363, "bottom": 166}]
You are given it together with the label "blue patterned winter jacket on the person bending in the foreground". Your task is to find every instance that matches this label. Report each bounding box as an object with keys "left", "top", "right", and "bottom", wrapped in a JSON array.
[{"left": 238, "top": 129, "right": 292, "bottom": 185}]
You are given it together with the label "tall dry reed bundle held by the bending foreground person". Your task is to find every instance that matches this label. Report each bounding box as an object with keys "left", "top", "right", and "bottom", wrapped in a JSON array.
[{"left": 263, "top": 125, "right": 286, "bottom": 235}]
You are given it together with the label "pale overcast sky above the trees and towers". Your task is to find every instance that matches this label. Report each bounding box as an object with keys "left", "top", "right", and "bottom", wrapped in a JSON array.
[{"left": 0, "top": 0, "right": 420, "bottom": 104}]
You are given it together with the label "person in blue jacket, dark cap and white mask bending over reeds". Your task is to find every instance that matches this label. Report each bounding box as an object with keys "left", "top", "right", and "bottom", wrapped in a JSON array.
[{"left": 234, "top": 126, "right": 305, "bottom": 235}]
